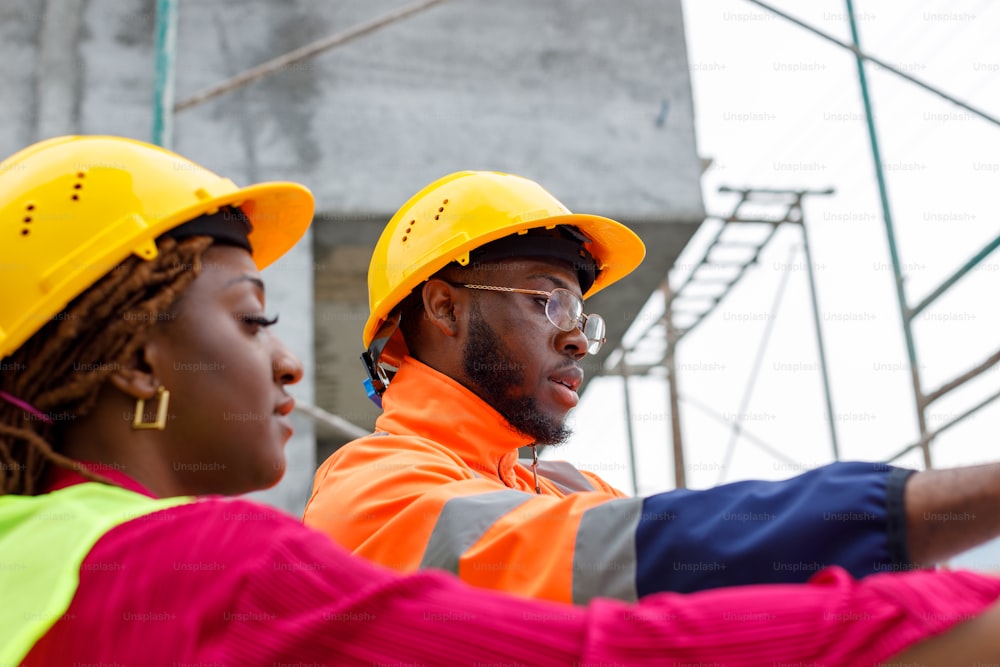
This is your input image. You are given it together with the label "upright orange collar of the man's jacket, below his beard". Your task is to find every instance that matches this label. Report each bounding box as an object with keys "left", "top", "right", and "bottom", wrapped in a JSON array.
[{"left": 375, "top": 357, "right": 532, "bottom": 486}]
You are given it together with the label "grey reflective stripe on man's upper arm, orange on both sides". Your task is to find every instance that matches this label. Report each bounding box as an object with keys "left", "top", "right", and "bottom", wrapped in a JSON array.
[{"left": 420, "top": 490, "right": 533, "bottom": 574}]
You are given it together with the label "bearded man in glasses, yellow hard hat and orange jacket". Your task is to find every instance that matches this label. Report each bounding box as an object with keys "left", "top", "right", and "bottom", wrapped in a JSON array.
[{"left": 305, "top": 172, "right": 1000, "bottom": 603}]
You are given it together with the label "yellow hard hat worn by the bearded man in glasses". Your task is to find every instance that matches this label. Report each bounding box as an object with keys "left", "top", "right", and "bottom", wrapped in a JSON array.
[{"left": 363, "top": 171, "right": 646, "bottom": 392}]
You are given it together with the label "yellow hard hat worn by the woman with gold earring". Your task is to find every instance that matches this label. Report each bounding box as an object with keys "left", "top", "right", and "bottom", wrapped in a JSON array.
[{"left": 0, "top": 136, "right": 313, "bottom": 358}]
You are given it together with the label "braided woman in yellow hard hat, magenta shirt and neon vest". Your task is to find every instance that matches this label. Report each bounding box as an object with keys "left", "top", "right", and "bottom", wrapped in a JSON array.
[{"left": 0, "top": 137, "right": 1000, "bottom": 666}]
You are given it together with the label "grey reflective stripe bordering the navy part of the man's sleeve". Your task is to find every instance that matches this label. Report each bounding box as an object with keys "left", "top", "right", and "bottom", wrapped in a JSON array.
[{"left": 573, "top": 498, "right": 642, "bottom": 604}]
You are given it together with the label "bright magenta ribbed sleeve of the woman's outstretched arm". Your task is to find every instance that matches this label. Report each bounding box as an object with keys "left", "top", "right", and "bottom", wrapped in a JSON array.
[{"left": 25, "top": 501, "right": 1000, "bottom": 667}]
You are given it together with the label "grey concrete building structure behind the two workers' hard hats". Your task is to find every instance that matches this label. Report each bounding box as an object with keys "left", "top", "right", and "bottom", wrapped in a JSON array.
[{"left": 0, "top": 0, "right": 704, "bottom": 512}]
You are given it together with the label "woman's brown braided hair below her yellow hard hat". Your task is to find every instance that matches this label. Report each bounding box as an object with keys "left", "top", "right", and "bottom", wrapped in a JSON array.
[{"left": 0, "top": 236, "right": 212, "bottom": 495}]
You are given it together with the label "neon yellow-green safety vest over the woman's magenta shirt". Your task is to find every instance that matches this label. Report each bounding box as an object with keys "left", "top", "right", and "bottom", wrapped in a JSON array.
[{"left": 0, "top": 482, "right": 194, "bottom": 667}]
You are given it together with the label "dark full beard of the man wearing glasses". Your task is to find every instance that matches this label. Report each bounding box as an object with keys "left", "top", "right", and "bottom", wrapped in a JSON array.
[{"left": 462, "top": 302, "right": 572, "bottom": 445}]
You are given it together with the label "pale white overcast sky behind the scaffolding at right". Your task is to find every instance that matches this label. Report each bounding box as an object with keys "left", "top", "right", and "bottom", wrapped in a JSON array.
[{"left": 546, "top": 0, "right": 1000, "bottom": 569}]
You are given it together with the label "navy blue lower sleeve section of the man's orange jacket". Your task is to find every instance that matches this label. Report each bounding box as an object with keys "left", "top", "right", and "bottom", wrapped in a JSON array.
[{"left": 635, "top": 463, "right": 913, "bottom": 596}]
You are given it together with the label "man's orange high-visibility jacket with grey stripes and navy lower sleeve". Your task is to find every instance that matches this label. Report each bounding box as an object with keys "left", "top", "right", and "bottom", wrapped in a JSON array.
[{"left": 304, "top": 358, "right": 908, "bottom": 603}]
